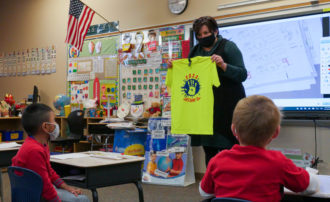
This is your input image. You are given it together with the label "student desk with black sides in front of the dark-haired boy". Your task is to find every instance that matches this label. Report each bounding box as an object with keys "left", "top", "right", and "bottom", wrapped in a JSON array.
[{"left": 50, "top": 153, "right": 144, "bottom": 202}]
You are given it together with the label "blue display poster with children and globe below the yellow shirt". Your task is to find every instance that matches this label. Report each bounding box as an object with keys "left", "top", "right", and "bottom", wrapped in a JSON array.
[{"left": 142, "top": 118, "right": 195, "bottom": 186}]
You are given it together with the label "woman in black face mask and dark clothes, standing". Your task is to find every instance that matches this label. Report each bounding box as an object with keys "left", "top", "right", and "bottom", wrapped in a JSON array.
[{"left": 168, "top": 16, "right": 248, "bottom": 166}]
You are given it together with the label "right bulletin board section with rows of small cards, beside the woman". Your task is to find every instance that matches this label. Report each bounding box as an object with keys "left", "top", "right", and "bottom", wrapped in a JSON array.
[{"left": 119, "top": 25, "right": 185, "bottom": 107}]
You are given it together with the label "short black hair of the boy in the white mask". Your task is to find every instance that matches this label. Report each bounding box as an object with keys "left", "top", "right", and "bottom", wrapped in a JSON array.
[{"left": 22, "top": 103, "right": 53, "bottom": 136}]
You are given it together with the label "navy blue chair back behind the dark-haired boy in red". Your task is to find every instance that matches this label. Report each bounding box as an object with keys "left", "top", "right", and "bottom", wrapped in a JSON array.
[{"left": 8, "top": 166, "right": 43, "bottom": 202}]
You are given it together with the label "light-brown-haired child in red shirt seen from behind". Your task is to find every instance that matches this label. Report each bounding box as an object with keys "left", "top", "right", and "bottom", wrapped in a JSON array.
[{"left": 199, "top": 95, "right": 319, "bottom": 202}]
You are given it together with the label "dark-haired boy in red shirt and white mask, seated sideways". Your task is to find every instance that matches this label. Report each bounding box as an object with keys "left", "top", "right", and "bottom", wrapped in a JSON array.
[{"left": 12, "top": 104, "right": 89, "bottom": 202}]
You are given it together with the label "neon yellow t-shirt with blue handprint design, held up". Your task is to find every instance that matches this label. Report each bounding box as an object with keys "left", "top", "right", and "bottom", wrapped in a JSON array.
[{"left": 166, "top": 56, "right": 220, "bottom": 135}]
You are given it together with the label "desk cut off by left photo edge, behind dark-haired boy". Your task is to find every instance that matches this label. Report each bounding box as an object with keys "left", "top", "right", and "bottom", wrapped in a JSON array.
[{"left": 0, "top": 147, "right": 19, "bottom": 201}]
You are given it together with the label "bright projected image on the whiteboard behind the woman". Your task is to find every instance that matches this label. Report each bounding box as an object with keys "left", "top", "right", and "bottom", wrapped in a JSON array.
[{"left": 219, "top": 14, "right": 330, "bottom": 99}]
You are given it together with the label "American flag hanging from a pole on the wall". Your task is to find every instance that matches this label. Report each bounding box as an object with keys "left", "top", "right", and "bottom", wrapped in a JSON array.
[{"left": 65, "top": 0, "right": 95, "bottom": 51}]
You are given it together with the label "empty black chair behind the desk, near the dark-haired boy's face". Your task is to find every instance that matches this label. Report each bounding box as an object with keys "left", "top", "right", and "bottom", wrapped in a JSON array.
[{"left": 51, "top": 110, "right": 85, "bottom": 153}]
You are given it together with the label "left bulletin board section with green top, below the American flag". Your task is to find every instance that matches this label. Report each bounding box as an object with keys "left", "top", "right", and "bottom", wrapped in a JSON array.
[{"left": 67, "top": 36, "right": 119, "bottom": 107}]
